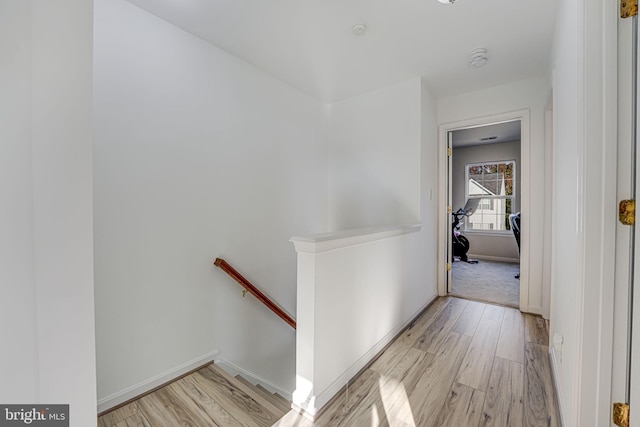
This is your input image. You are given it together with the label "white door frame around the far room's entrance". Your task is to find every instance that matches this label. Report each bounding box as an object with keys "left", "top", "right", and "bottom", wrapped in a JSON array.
[{"left": 438, "top": 109, "right": 531, "bottom": 312}]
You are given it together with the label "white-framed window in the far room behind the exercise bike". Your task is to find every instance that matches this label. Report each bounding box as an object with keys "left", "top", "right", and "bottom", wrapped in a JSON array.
[{"left": 465, "top": 160, "right": 516, "bottom": 232}]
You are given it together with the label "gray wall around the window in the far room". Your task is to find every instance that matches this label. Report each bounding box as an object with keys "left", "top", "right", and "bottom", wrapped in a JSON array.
[{"left": 451, "top": 141, "right": 522, "bottom": 260}]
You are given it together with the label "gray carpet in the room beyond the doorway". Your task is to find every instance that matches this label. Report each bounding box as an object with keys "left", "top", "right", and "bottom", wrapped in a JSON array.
[{"left": 451, "top": 260, "right": 520, "bottom": 308}]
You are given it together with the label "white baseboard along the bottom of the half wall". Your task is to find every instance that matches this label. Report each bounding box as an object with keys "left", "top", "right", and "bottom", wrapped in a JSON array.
[{"left": 294, "top": 295, "right": 438, "bottom": 420}]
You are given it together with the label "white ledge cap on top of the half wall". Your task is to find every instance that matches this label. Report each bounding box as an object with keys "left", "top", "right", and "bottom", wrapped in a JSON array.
[{"left": 289, "top": 224, "right": 422, "bottom": 254}]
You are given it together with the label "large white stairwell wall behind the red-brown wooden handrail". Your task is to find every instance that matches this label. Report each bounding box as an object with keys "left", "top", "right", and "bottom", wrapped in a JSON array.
[{"left": 94, "top": 0, "right": 327, "bottom": 406}]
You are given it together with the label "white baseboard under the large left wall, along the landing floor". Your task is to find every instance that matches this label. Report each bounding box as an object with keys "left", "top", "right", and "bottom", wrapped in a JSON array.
[{"left": 98, "top": 350, "right": 219, "bottom": 413}]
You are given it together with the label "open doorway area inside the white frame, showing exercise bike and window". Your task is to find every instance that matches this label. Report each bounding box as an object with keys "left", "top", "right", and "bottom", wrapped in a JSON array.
[{"left": 448, "top": 120, "right": 521, "bottom": 308}]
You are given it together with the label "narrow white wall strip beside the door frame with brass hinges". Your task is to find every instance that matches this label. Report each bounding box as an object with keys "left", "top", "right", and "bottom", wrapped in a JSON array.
[{"left": 550, "top": 1, "right": 583, "bottom": 425}]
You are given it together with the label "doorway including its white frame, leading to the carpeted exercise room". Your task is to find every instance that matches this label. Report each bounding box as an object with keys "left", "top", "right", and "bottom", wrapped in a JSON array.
[{"left": 438, "top": 110, "right": 529, "bottom": 311}]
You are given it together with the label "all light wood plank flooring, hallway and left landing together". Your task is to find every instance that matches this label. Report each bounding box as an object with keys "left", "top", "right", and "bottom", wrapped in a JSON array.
[{"left": 98, "top": 298, "right": 559, "bottom": 427}]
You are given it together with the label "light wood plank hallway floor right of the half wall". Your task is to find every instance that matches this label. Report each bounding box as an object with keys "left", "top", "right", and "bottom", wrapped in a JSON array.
[{"left": 276, "top": 298, "right": 560, "bottom": 427}]
